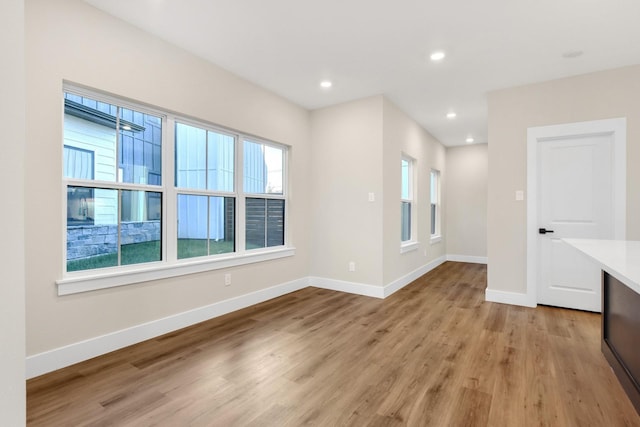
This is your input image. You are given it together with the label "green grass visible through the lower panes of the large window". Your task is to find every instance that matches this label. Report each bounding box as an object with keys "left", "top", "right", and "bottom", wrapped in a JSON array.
[{"left": 67, "top": 239, "right": 234, "bottom": 271}]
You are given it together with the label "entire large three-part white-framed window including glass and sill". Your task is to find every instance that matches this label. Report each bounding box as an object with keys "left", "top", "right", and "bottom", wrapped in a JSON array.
[{"left": 56, "top": 84, "right": 294, "bottom": 295}]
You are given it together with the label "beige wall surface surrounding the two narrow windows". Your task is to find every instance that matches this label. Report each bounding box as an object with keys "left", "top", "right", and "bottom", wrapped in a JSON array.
[{"left": 383, "top": 99, "right": 448, "bottom": 284}]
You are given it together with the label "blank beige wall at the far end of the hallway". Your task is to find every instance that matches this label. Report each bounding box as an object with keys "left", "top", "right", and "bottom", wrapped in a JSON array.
[{"left": 443, "top": 144, "right": 489, "bottom": 259}]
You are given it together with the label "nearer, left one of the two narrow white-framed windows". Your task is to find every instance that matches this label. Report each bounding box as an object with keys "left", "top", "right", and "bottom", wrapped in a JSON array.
[{"left": 400, "top": 155, "right": 417, "bottom": 252}]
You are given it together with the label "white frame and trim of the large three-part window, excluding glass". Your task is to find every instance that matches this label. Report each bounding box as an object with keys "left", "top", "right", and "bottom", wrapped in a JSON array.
[{"left": 55, "top": 83, "right": 296, "bottom": 295}]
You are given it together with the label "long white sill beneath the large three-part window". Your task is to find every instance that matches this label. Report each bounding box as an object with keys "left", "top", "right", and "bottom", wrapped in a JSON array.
[{"left": 56, "top": 247, "right": 296, "bottom": 296}]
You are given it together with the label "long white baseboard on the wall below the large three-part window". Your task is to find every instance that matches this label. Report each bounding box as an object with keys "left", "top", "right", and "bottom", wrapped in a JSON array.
[{"left": 26, "top": 277, "right": 309, "bottom": 379}]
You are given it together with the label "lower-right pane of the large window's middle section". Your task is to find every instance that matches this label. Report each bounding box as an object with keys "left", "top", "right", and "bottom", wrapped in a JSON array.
[{"left": 209, "top": 197, "right": 236, "bottom": 255}]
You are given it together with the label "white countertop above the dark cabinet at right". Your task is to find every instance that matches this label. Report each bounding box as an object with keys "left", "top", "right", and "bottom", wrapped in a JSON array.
[{"left": 562, "top": 239, "right": 640, "bottom": 294}]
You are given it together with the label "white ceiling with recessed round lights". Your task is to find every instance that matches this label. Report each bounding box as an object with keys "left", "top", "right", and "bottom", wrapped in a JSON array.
[{"left": 85, "top": 0, "right": 640, "bottom": 146}]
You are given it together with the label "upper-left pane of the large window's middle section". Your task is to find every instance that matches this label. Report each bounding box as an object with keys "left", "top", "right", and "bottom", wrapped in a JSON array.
[{"left": 176, "top": 123, "right": 207, "bottom": 189}]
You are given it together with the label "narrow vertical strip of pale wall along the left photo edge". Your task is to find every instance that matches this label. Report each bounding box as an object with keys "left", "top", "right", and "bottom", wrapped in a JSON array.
[{"left": 0, "top": 0, "right": 26, "bottom": 426}]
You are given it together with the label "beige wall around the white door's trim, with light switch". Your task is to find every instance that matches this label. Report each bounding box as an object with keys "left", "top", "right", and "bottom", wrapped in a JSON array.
[{"left": 488, "top": 65, "right": 640, "bottom": 294}]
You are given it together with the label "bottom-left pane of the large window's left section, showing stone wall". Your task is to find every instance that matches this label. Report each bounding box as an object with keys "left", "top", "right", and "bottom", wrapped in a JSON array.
[{"left": 67, "top": 186, "right": 118, "bottom": 271}]
